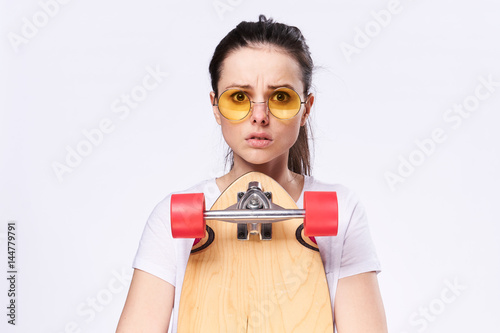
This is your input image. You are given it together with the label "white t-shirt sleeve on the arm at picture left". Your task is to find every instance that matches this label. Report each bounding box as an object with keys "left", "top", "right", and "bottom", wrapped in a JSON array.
[{"left": 132, "top": 195, "right": 176, "bottom": 286}]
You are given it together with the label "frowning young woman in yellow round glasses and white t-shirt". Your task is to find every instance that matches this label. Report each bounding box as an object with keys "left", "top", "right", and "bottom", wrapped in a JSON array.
[{"left": 117, "top": 15, "right": 387, "bottom": 333}]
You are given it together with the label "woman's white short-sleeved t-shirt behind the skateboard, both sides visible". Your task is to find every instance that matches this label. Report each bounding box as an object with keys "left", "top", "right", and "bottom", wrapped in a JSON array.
[{"left": 133, "top": 176, "right": 380, "bottom": 332}]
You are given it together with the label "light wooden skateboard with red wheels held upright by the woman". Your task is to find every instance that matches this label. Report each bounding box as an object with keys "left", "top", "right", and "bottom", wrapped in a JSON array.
[{"left": 170, "top": 172, "right": 338, "bottom": 333}]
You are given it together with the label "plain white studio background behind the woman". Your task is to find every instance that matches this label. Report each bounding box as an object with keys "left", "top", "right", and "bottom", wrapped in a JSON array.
[{"left": 0, "top": 0, "right": 500, "bottom": 333}]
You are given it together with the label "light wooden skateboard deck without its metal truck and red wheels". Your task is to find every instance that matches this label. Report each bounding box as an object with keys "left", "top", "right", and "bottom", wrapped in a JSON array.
[{"left": 178, "top": 172, "right": 334, "bottom": 333}]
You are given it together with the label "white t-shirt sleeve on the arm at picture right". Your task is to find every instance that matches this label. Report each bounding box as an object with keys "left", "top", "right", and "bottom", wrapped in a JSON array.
[{"left": 339, "top": 189, "right": 380, "bottom": 278}]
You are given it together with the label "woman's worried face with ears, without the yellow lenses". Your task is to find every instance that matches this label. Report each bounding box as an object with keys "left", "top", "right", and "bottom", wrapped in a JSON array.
[{"left": 210, "top": 46, "right": 314, "bottom": 164}]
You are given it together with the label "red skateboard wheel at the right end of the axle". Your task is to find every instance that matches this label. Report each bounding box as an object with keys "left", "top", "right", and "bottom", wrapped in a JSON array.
[{"left": 304, "top": 191, "right": 338, "bottom": 237}]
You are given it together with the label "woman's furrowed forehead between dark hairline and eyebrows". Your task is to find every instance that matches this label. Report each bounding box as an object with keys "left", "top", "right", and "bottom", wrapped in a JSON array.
[{"left": 218, "top": 46, "right": 303, "bottom": 91}]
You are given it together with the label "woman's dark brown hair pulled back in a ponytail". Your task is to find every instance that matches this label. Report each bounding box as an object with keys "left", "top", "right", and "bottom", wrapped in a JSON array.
[{"left": 209, "top": 15, "right": 314, "bottom": 175}]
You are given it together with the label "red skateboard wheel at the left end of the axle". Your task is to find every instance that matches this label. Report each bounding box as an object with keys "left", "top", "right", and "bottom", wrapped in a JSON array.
[{"left": 170, "top": 193, "right": 205, "bottom": 238}]
